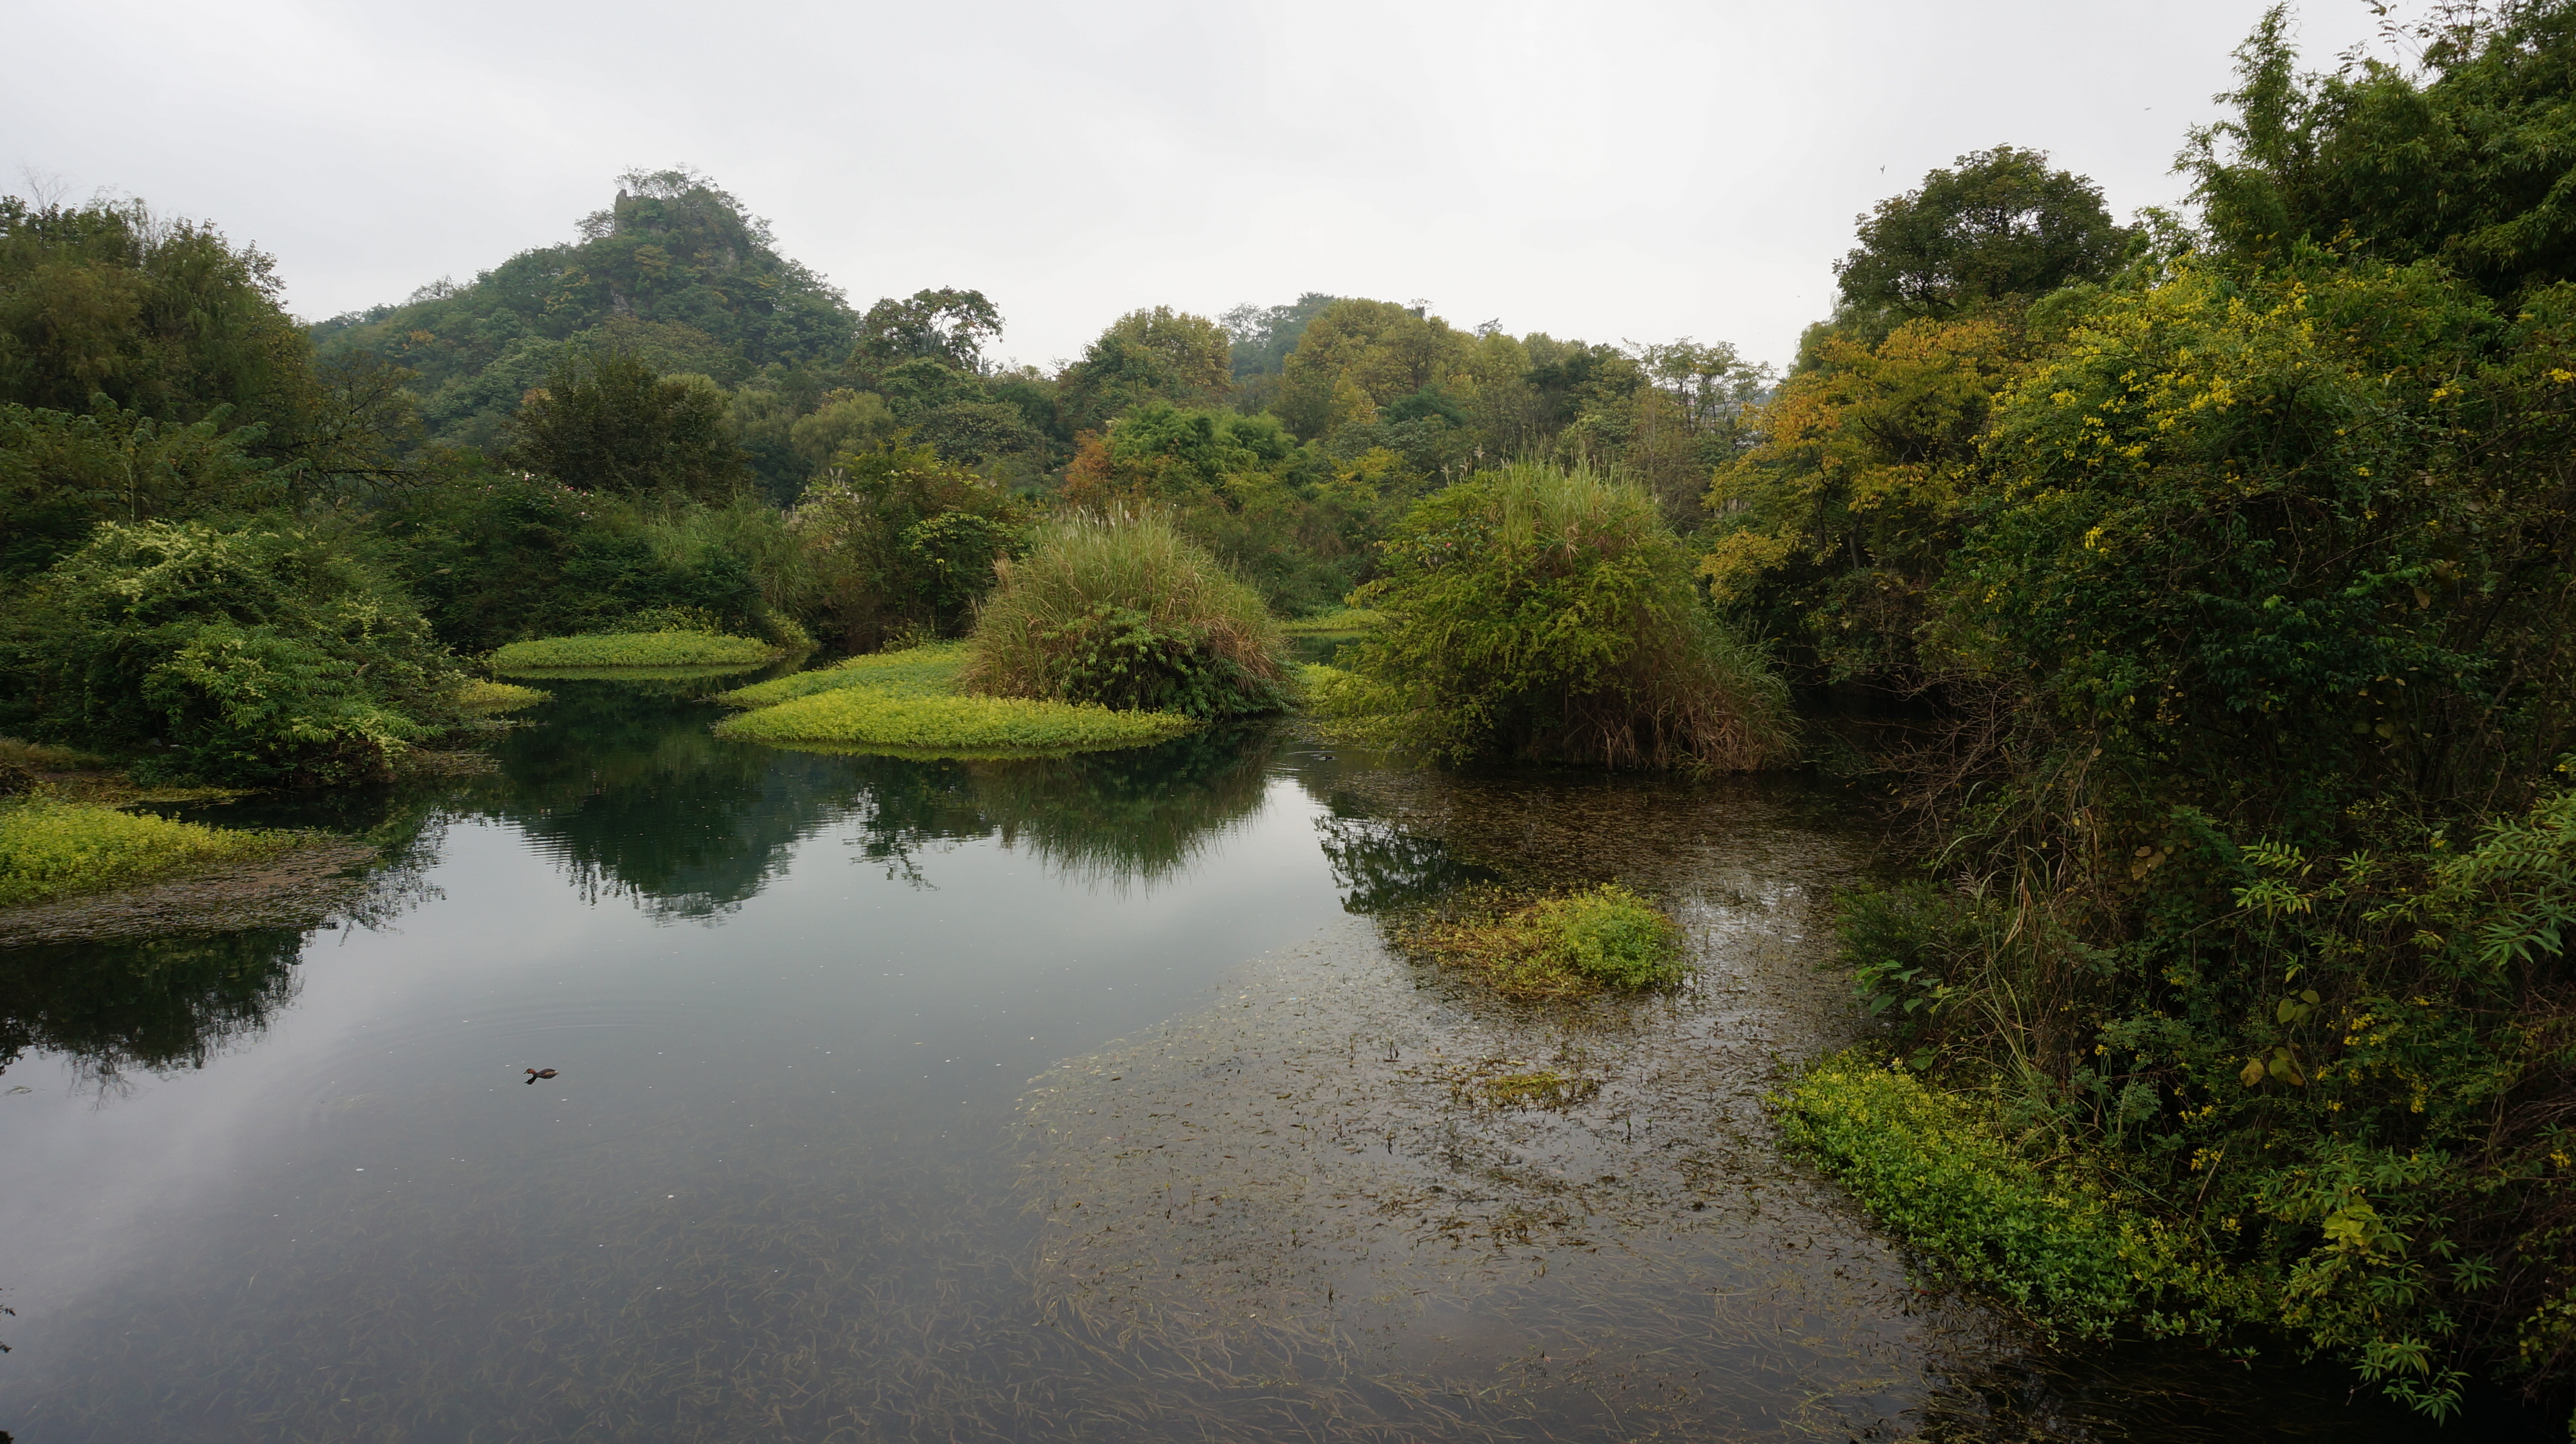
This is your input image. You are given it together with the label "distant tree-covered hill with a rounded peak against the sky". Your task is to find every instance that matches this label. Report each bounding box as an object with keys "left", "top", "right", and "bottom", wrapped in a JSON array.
[{"left": 312, "top": 170, "right": 858, "bottom": 448}]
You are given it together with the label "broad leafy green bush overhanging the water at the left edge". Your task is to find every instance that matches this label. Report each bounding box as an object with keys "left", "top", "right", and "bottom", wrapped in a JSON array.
[{"left": 0, "top": 523, "right": 461, "bottom": 785}]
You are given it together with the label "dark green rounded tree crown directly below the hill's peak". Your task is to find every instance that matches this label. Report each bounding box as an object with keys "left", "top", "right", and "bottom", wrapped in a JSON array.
[{"left": 508, "top": 352, "right": 749, "bottom": 502}]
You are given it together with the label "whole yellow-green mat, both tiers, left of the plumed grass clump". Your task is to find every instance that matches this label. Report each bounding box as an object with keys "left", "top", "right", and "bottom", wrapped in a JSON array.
[{"left": 716, "top": 643, "right": 1198, "bottom": 757}]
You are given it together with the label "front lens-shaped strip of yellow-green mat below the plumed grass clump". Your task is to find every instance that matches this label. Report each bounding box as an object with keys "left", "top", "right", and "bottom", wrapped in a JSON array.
[{"left": 716, "top": 687, "right": 1198, "bottom": 757}]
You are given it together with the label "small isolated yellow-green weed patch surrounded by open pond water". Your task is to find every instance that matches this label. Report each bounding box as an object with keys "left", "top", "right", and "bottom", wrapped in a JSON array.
[{"left": 1393, "top": 883, "right": 1684, "bottom": 999}]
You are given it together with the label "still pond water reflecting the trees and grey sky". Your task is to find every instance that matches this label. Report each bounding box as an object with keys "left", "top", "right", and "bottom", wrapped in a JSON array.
[{"left": 0, "top": 679, "right": 2545, "bottom": 1444}]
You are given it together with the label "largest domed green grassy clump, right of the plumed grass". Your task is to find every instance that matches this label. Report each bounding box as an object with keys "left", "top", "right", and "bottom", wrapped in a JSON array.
[{"left": 1316, "top": 464, "right": 1790, "bottom": 770}]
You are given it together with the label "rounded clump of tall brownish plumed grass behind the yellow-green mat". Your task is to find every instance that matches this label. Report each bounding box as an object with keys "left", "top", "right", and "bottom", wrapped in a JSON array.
[{"left": 961, "top": 512, "right": 1288, "bottom": 718}]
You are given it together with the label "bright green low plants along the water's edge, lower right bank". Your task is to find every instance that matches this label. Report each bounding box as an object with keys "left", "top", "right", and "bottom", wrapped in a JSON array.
[{"left": 1775, "top": 1045, "right": 2251, "bottom": 1339}]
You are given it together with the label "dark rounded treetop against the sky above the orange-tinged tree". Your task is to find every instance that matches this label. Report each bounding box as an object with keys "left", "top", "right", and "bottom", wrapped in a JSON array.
[{"left": 1834, "top": 144, "right": 2138, "bottom": 334}]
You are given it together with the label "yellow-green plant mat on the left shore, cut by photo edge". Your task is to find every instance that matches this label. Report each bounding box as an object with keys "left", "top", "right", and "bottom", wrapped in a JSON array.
[{"left": 0, "top": 798, "right": 294, "bottom": 906}]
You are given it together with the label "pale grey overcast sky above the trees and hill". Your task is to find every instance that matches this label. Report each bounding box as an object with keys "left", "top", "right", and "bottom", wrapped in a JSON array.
[{"left": 0, "top": 0, "right": 2375, "bottom": 363}]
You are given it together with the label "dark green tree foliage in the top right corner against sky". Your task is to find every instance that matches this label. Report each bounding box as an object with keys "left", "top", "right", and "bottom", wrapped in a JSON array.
[{"left": 2182, "top": 0, "right": 2576, "bottom": 296}]
